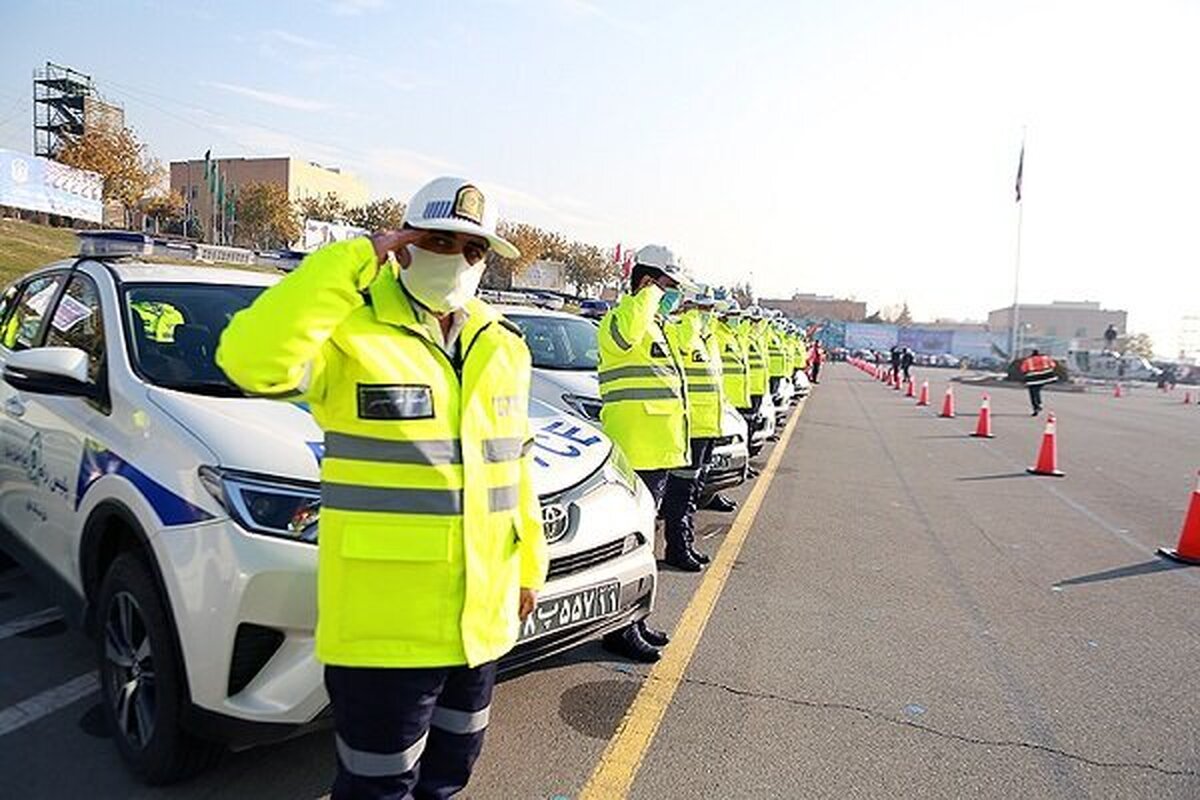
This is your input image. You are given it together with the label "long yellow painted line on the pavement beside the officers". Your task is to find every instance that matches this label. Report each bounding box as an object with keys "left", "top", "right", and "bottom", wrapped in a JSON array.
[{"left": 578, "top": 401, "right": 808, "bottom": 800}]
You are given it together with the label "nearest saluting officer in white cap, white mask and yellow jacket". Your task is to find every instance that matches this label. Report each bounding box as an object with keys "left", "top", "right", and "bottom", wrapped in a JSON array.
[{"left": 217, "top": 178, "right": 547, "bottom": 800}]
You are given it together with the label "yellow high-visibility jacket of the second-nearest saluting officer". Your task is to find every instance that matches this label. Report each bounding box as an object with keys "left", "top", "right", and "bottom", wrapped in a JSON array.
[{"left": 598, "top": 285, "right": 691, "bottom": 470}]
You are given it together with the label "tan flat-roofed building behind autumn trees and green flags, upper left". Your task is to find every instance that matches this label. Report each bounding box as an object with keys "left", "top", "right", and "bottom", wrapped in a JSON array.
[{"left": 170, "top": 156, "right": 367, "bottom": 241}]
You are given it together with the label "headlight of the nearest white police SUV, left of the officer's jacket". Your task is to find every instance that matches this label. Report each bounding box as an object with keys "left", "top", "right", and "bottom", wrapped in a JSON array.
[{"left": 199, "top": 467, "right": 320, "bottom": 545}]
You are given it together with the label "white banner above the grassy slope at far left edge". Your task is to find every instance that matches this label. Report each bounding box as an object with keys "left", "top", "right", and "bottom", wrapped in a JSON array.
[{"left": 0, "top": 149, "right": 104, "bottom": 222}]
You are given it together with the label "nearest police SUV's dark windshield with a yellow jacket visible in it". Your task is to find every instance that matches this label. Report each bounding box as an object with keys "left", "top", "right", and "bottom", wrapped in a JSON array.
[{"left": 124, "top": 283, "right": 264, "bottom": 397}]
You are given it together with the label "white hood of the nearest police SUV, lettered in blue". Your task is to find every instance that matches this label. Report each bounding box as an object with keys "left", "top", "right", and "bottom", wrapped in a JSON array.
[{"left": 149, "top": 387, "right": 612, "bottom": 495}]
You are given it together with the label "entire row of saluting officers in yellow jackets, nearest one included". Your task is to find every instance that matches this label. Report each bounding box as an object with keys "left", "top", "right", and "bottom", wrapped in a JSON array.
[{"left": 216, "top": 178, "right": 805, "bottom": 800}]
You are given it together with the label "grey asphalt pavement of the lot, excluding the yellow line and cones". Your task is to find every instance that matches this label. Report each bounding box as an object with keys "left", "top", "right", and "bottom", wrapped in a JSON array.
[{"left": 0, "top": 365, "right": 1200, "bottom": 800}]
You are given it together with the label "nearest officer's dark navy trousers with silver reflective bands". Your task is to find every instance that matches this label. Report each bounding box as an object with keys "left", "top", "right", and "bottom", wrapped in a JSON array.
[{"left": 325, "top": 661, "right": 496, "bottom": 800}]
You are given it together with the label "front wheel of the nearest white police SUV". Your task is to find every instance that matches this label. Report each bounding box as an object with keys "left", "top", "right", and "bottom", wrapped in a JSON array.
[{"left": 96, "top": 553, "right": 224, "bottom": 784}]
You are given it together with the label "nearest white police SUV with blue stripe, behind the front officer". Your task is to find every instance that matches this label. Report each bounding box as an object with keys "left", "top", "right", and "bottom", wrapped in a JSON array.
[{"left": 0, "top": 234, "right": 656, "bottom": 782}]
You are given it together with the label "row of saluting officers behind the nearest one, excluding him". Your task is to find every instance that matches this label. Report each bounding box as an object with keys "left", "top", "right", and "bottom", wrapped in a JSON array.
[{"left": 599, "top": 245, "right": 808, "bottom": 662}]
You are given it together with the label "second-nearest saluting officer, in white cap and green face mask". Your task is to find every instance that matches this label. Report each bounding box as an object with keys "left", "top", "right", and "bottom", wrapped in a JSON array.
[{"left": 598, "top": 245, "right": 690, "bottom": 662}]
